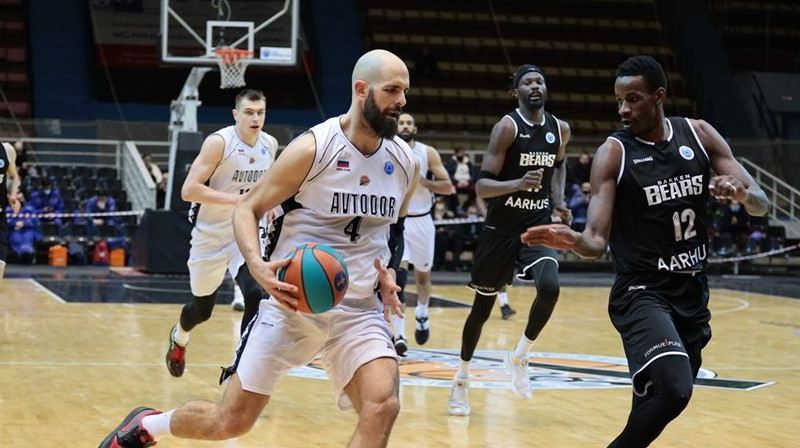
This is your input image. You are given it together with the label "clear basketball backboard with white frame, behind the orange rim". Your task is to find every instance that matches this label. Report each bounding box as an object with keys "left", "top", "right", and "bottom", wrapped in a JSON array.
[{"left": 160, "top": 0, "right": 300, "bottom": 66}]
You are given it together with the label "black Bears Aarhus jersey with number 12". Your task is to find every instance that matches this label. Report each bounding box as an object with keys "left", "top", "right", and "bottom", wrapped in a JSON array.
[{"left": 609, "top": 117, "right": 711, "bottom": 274}]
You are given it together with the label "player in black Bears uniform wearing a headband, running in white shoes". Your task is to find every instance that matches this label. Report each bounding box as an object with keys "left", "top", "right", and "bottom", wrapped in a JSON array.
[{"left": 448, "top": 64, "right": 570, "bottom": 415}]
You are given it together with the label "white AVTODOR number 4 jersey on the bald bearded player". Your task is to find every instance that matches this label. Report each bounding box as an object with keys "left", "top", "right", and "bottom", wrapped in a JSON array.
[{"left": 269, "top": 117, "right": 415, "bottom": 307}]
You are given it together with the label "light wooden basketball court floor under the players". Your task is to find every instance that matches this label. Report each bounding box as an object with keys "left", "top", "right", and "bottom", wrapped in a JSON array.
[{"left": 0, "top": 279, "right": 800, "bottom": 448}]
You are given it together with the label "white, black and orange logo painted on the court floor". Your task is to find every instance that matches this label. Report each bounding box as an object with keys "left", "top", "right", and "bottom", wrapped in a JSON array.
[{"left": 289, "top": 347, "right": 775, "bottom": 390}]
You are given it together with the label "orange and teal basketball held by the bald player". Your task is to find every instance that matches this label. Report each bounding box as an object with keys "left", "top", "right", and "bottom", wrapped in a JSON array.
[{"left": 278, "top": 243, "right": 349, "bottom": 314}]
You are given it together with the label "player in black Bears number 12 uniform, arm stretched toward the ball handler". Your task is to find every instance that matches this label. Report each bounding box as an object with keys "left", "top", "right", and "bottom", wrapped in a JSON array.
[{"left": 521, "top": 56, "right": 769, "bottom": 448}]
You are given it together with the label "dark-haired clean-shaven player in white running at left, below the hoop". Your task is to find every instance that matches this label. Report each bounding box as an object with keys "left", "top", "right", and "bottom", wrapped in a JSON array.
[{"left": 166, "top": 89, "right": 278, "bottom": 376}]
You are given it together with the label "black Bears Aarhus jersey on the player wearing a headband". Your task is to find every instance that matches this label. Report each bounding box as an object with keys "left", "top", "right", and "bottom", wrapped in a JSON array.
[{"left": 486, "top": 109, "right": 561, "bottom": 234}]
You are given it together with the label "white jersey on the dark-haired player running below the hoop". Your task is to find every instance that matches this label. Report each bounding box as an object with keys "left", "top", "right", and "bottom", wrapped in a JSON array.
[{"left": 189, "top": 126, "right": 278, "bottom": 239}]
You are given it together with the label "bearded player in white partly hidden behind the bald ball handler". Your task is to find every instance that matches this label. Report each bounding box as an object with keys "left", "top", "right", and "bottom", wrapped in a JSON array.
[{"left": 393, "top": 113, "right": 456, "bottom": 356}]
